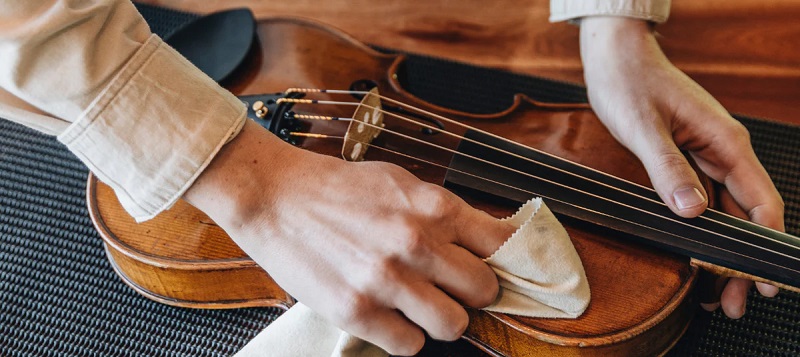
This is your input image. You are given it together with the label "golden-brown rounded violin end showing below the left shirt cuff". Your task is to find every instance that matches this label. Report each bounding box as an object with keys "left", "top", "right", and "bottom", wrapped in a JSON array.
[{"left": 87, "top": 176, "right": 294, "bottom": 308}]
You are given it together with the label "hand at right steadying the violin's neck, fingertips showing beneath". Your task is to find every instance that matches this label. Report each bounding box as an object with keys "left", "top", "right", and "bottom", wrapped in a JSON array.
[{"left": 580, "top": 17, "right": 784, "bottom": 318}]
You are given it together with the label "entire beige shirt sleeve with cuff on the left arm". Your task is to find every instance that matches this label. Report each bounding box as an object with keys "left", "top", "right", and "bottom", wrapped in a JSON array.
[{"left": 0, "top": 0, "right": 246, "bottom": 221}]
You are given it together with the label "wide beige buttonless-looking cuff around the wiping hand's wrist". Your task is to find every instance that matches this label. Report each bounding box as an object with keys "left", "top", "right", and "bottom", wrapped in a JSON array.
[{"left": 58, "top": 35, "right": 247, "bottom": 222}]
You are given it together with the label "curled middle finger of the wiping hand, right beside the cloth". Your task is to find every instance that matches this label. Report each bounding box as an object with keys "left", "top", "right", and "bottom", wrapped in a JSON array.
[{"left": 426, "top": 245, "right": 500, "bottom": 308}]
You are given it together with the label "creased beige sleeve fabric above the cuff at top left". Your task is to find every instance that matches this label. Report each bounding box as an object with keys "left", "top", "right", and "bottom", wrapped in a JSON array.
[{"left": 0, "top": 0, "right": 151, "bottom": 122}]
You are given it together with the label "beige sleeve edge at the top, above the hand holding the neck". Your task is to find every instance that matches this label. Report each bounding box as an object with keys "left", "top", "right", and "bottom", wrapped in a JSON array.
[{"left": 550, "top": 0, "right": 671, "bottom": 23}]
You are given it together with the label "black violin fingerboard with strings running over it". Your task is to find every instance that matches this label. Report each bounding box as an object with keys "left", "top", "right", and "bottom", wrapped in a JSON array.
[{"left": 445, "top": 130, "right": 800, "bottom": 287}]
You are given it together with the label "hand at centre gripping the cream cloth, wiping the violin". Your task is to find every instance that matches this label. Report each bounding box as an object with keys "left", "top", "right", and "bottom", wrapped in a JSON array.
[{"left": 185, "top": 122, "right": 514, "bottom": 355}]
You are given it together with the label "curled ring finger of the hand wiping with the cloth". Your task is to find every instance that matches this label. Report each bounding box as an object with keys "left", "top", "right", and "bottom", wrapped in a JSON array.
[{"left": 393, "top": 281, "right": 469, "bottom": 341}]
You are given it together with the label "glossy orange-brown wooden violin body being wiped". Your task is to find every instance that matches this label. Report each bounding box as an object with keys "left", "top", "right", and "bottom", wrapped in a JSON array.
[{"left": 87, "top": 19, "right": 713, "bottom": 356}]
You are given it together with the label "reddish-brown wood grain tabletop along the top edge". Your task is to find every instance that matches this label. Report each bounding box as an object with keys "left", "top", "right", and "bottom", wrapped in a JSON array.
[{"left": 140, "top": 0, "right": 800, "bottom": 124}]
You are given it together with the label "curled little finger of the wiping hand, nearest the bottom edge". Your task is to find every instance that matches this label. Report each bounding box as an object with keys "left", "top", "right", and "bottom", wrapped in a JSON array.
[{"left": 343, "top": 309, "right": 425, "bottom": 356}]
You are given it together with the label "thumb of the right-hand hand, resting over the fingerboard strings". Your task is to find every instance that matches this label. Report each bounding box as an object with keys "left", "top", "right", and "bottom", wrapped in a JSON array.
[{"left": 627, "top": 119, "right": 708, "bottom": 218}]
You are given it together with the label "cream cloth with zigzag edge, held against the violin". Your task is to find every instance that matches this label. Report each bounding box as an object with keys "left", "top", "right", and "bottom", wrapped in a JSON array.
[{"left": 236, "top": 197, "right": 590, "bottom": 357}]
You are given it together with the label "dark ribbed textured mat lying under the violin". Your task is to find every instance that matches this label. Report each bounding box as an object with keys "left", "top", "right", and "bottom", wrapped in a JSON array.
[{"left": 0, "top": 6, "right": 800, "bottom": 356}]
